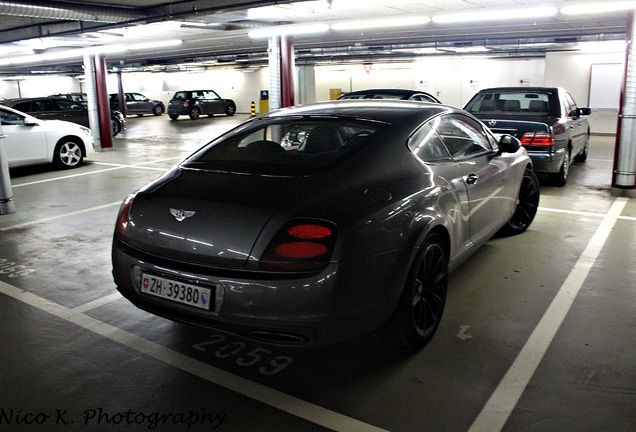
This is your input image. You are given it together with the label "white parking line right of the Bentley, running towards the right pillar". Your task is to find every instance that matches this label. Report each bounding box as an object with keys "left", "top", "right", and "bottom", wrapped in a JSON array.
[{"left": 469, "top": 198, "right": 627, "bottom": 432}]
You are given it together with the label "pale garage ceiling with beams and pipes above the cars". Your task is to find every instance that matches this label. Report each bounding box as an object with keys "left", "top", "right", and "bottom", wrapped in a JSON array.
[{"left": 0, "top": 0, "right": 628, "bottom": 76}]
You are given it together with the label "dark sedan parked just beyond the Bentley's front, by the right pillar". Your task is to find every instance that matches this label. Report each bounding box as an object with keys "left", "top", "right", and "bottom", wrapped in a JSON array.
[{"left": 464, "top": 87, "right": 591, "bottom": 186}]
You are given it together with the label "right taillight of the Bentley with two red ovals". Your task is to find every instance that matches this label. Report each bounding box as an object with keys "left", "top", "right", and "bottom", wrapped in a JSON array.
[{"left": 259, "top": 220, "right": 336, "bottom": 272}]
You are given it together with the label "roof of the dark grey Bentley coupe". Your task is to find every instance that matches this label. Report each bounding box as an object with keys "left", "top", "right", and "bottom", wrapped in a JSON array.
[{"left": 261, "top": 99, "right": 454, "bottom": 123}]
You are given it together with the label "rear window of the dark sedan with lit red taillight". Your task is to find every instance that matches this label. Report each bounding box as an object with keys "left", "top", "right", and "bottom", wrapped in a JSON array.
[{"left": 465, "top": 91, "right": 550, "bottom": 116}]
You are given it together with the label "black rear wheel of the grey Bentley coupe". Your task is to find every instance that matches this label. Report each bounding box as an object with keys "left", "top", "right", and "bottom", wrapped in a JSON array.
[{"left": 390, "top": 234, "right": 448, "bottom": 349}]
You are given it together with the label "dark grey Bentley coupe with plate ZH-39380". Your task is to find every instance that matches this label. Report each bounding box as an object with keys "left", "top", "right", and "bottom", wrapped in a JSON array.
[{"left": 112, "top": 101, "right": 539, "bottom": 348}]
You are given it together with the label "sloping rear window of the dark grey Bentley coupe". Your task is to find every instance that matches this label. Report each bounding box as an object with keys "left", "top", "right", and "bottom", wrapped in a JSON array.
[{"left": 182, "top": 117, "right": 389, "bottom": 176}]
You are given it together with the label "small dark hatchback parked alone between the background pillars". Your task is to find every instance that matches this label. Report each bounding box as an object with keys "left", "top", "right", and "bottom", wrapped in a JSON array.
[{"left": 168, "top": 90, "right": 236, "bottom": 120}]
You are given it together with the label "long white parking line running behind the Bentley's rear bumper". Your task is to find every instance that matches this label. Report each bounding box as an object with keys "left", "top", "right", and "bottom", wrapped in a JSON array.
[{"left": 0, "top": 281, "right": 386, "bottom": 432}]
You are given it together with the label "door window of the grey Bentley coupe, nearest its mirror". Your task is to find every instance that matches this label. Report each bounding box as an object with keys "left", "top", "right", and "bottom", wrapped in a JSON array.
[{"left": 435, "top": 114, "right": 493, "bottom": 159}]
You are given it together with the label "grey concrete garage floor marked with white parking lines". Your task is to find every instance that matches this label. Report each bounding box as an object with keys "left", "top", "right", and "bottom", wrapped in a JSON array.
[{"left": 0, "top": 115, "right": 636, "bottom": 432}]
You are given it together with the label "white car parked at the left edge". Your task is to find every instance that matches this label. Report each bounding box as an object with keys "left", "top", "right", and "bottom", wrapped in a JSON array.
[{"left": 0, "top": 105, "right": 93, "bottom": 168}]
